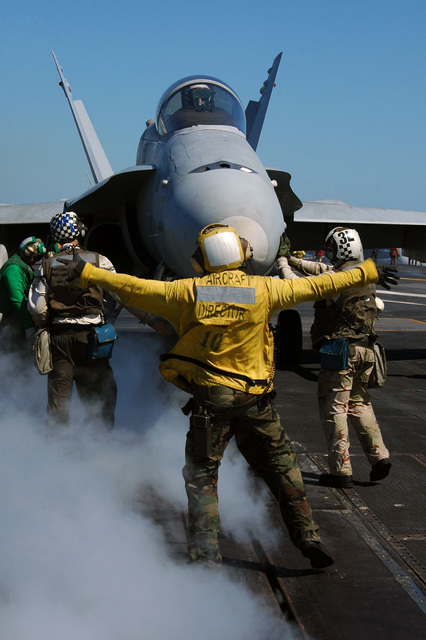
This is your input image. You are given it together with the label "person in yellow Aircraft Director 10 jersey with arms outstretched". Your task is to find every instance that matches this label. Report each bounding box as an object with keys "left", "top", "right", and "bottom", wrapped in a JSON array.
[{"left": 58, "top": 224, "right": 396, "bottom": 568}]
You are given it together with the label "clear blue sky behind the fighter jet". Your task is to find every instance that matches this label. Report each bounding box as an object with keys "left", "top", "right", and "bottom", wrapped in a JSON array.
[{"left": 0, "top": 0, "right": 426, "bottom": 211}]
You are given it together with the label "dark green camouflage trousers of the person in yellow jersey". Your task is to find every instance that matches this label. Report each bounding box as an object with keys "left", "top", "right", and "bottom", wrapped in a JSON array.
[{"left": 183, "top": 386, "right": 320, "bottom": 563}]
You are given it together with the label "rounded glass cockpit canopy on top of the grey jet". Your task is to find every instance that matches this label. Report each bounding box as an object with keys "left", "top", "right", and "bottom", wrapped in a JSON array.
[{"left": 156, "top": 76, "right": 246, "bottom": 135}]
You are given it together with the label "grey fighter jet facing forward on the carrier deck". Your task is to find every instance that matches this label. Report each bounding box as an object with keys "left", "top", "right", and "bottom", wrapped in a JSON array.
[{"left": 0, "top": 51, "right": 426, "bottom": 278}]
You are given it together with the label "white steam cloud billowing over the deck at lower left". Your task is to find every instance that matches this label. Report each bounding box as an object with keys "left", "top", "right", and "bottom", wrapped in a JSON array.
[{"left": 0, "top": 334, "right": 298, "bottom": 640}]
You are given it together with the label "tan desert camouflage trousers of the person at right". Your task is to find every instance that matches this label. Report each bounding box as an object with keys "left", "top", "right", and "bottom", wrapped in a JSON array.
[{"left": 318, "top": 343, "right": 389, "bottom": 476}]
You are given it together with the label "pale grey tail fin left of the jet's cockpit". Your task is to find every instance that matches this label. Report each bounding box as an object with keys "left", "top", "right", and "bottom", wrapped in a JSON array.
[{"left": 52, "top": 51, "right": 114, "bottom": 184}]
